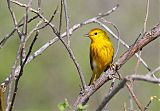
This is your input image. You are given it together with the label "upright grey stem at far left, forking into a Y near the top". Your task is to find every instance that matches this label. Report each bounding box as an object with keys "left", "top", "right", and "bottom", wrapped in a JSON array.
[{"left": 6, "top": 0, "right": 31, "bottom": 111}]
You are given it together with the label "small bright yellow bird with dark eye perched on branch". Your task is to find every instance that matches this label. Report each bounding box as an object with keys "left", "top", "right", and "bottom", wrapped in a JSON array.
[{"left": 86, "top": 28, "right": 114, "bottom": 85}]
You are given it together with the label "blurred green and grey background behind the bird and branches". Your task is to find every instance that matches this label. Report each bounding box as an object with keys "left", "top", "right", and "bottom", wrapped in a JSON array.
[{"left": 0, "top": 0, "right": 160, "bottom": 111}]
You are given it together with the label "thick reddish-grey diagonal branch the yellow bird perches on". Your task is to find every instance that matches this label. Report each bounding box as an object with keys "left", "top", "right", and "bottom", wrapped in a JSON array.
[{"left": 75, "top": 24, "right": 160, "bottom": 106}]
